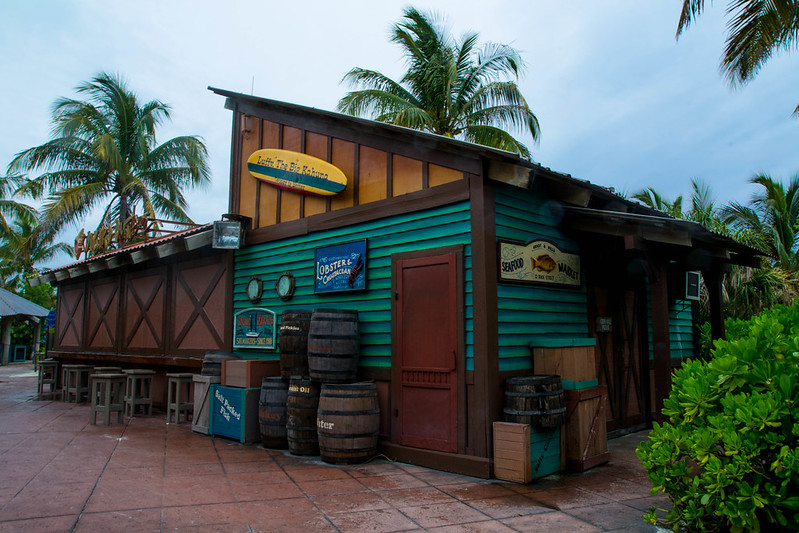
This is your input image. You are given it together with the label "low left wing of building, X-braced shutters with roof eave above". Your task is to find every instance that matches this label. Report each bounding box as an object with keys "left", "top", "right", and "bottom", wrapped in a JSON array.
[{"left": 31, "top": 225, "right": 233, "bottom": 403}]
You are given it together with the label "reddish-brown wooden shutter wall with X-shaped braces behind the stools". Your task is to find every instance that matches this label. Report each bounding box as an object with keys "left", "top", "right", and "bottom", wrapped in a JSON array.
[{"left": 54, "top": 253, "right": 232, "bottom": 360}]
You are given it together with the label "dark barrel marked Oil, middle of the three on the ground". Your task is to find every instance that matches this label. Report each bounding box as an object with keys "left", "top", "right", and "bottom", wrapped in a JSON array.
[{"left": 286, "top": 378, "right": 319, "bottom": 455}]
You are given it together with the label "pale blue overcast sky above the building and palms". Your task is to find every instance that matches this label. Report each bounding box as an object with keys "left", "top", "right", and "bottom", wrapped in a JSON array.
[{"left": 0, "top": 0, "right": 799, "bottom": 264}]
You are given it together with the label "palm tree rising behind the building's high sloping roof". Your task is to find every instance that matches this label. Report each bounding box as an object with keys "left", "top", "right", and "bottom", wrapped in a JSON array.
[{"left": 338, "top": 8, "right": 540, "bottom": 158}]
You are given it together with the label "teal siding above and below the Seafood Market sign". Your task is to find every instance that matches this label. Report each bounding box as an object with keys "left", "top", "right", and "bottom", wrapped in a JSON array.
[{"left": 495, "top": 186, "right": 588, "bottom": 371}]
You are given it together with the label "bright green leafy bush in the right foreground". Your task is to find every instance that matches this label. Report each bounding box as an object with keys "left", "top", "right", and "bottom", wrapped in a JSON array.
[{"left": 636, "top": 307, "right": 799, "bottom": 532}]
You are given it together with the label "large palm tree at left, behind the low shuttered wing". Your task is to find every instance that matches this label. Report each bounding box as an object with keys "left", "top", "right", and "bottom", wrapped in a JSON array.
[{"left": 9, "top": 73, "right": 210, "bottom": 234}]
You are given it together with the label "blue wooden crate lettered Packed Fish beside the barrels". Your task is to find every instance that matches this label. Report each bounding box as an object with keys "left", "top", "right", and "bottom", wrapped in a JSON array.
[{"left": 208, "top": 385, "right": 261, "bottom": 443}]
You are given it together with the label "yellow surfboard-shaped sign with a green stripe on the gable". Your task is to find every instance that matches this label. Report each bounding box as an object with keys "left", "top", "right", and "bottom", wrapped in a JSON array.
[{"left": 247, "top": 148, "right": 347, "bottom": 196}]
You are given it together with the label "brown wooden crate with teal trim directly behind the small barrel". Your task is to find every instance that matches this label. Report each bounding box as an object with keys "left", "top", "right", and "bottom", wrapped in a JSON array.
[{"left": 531, "top": 346, "right": 597, "bottom": 384}]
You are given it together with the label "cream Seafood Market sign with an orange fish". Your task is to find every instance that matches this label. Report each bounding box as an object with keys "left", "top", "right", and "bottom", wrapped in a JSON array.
[{"left": 497, "top": 239, "right": 581, "bottom": 287}]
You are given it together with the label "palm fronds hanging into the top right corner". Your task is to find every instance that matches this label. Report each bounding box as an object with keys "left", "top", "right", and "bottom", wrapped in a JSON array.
[{"left": 677, "top": 0, "right": 799, "bottom": 114}]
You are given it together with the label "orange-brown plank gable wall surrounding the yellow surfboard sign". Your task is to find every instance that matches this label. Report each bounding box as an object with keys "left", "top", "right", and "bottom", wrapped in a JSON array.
[{"left": 238, "top": 115, "right": 464, "bottom": 229}]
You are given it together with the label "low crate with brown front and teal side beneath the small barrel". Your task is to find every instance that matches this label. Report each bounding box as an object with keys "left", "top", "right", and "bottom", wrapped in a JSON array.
[{"left": 494, "top": 422, "right": 561, "bottom": 483}]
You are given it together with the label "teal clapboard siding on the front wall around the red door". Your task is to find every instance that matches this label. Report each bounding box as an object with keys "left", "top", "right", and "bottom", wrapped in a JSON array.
[{"left": 233, "top": 202, "right": 474, "bottom": 368}]
